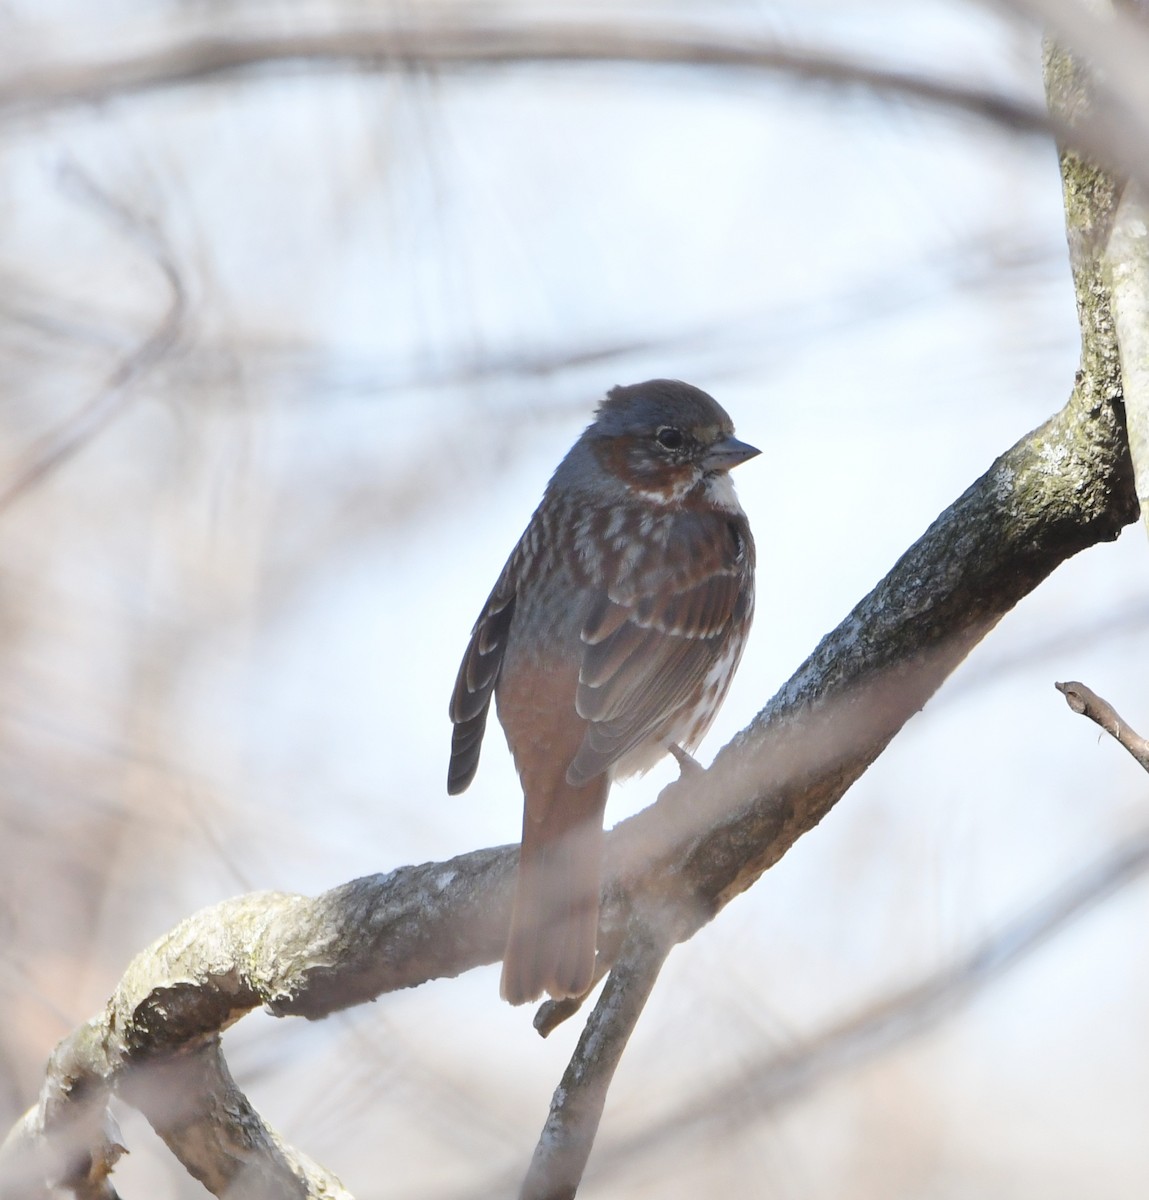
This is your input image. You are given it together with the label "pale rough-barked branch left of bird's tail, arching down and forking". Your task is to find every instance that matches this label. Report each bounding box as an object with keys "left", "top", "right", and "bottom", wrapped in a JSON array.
[{"left": 0, "top": 868, "right": 515, "bottom": 1200}]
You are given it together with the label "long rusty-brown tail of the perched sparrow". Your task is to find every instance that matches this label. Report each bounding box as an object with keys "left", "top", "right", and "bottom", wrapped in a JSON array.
[{"left": 500, "top": 775, "right": 610, "bottom": 1004}]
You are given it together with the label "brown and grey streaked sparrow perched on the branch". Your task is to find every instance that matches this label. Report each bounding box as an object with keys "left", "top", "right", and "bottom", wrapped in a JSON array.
[{"left": 447, "top": 379, "right": 760, "bottom": 1004}]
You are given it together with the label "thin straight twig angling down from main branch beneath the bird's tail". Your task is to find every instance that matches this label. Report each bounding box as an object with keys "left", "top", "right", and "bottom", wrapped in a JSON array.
[{"left": 519, "top": 914, "right": 674, "bottom": 1200}]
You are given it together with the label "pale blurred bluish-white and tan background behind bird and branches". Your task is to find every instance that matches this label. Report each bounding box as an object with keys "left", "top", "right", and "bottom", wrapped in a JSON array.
[{"left": 0, "top": 0, "right": 1149, "bottom": 1200}]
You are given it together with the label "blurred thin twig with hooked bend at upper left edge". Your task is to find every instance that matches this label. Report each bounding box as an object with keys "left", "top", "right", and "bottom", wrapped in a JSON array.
[{"left": 0, "top": 166, "right": 187, "bottom": 514}]
